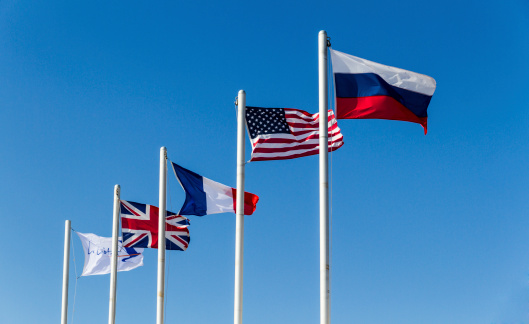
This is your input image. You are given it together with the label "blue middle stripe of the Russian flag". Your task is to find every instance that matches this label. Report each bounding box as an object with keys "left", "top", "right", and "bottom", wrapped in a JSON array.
[{"left": 334, "top": 73, "right": 432, "bottom": 117}]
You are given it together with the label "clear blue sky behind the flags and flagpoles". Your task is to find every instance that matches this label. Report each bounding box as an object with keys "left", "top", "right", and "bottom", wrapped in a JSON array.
[{"left": 0, "top": 0, "right": 529, "bottom": 324}]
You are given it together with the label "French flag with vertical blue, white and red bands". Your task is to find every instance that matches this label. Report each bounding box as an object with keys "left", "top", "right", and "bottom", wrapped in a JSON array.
[{"left": 171, "top": 162, "right": 259, "bottom": 216}]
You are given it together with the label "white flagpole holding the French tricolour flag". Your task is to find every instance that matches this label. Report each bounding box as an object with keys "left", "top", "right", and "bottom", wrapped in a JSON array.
[{"left": 156, "top": 147, "right": 167, "bottom": 324}]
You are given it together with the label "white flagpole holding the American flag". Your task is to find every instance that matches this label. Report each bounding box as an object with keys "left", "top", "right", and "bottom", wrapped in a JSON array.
[{"left": 233, "top": 90, "right": 246, "bottom": 324}]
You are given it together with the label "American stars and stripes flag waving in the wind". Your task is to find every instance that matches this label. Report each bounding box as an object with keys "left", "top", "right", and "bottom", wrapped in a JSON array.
[{"left": 246, "top": 107, "right": 343, "bottom": 161}]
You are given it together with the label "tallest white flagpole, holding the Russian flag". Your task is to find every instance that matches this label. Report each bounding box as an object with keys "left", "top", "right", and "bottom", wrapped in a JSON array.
[{"left": 318, "top": 30, "right": 331, "bottom": 324}]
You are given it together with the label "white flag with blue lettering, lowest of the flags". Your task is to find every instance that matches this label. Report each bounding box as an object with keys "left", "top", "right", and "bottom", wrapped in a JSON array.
[{"left": 76, "top": 232, "right": 143, "bottom": 276}]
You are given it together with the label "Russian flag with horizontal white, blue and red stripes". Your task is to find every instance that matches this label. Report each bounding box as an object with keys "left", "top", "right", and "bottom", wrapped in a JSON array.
[{"left": 331, "top": 49, "right": 436, "bottom": 134}]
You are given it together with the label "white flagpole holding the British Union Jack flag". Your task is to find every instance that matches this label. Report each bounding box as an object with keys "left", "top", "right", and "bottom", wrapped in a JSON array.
[{"left": 108, "top": 185, "right": 120, "bottom": 324}]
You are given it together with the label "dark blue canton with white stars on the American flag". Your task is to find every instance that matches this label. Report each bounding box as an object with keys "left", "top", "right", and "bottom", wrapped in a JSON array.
[{"left": 246, "top": 107, "right": 290, "bottom": 138}]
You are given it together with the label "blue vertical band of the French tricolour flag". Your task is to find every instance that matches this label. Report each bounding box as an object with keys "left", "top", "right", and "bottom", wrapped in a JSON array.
[{"left": 171, "top": 162, "right": 208, "bottom": 216}]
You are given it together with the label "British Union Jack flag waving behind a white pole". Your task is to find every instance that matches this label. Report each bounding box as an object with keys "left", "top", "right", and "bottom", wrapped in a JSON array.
[{"left": 121, "top": 200, "right": 190, "bottom": 251}]
